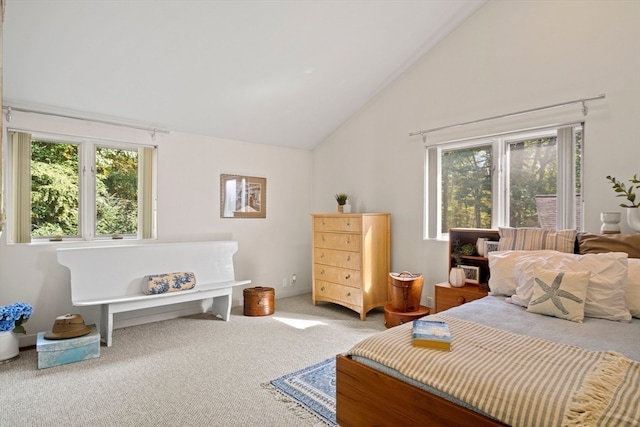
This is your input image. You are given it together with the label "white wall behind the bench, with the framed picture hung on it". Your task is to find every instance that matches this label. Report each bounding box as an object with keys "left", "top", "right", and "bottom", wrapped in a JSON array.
[{"left": 0, "top": 111, "right": 312, "bottom": 346}]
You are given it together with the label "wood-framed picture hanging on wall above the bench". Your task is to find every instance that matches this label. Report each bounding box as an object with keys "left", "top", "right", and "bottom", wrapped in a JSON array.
[{"left": 220, "top": 174, "right": 267, "bottom": 218}]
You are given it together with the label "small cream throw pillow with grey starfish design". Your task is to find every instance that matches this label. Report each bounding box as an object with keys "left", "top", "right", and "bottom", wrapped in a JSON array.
[{"left": 527, "top": 267, "right": 591, "bottom": 323}]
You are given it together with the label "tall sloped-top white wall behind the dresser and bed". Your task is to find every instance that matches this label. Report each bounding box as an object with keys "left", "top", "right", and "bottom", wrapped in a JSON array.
[{"left": 313, "top": 1, "right": 640, "bottom": 301}]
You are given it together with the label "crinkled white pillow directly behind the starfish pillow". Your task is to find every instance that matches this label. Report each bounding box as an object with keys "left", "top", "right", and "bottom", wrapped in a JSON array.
[{"left": 507, "top": 252, "right": 631, "bottom": 322}]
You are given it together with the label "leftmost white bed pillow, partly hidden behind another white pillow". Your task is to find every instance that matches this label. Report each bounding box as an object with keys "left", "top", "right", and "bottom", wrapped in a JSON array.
[{"left": 488, "top": 250, "right": 559, "bottom": 297}]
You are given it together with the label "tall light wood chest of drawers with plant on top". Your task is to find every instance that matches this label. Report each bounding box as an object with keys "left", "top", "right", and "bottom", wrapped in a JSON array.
[{"left": 312, "top": 213, "right": 391, "bottom": 320}]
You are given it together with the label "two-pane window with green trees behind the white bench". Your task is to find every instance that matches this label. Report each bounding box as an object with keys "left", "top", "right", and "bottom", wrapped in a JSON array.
[{"left": 11, "top": 132, "right": 155, "bottom": 243}]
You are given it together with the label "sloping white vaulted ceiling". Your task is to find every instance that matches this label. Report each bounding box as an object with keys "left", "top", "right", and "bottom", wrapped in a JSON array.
[{"left": 3, "top": 0, "right": 484, "bottom": 149}]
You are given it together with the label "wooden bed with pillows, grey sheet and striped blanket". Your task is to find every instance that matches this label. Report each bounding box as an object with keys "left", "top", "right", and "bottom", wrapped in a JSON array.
[{"left": 336, "top": 230, "right": 640, "bottom": 427}]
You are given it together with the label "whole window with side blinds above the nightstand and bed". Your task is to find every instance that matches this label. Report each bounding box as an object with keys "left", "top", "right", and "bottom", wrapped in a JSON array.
[{"left": 426, "top": 125, "right": 582, "bottom": 238}]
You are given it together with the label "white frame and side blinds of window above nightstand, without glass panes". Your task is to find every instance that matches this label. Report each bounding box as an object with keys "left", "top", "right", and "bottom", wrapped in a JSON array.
[{"left": 423, "top": 122, "right": 585, "bottom": 240}]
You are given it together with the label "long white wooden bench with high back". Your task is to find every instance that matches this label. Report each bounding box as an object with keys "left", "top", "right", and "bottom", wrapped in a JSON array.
[{"left": 57, "top": 241, "right": 251, "bottom": 347}]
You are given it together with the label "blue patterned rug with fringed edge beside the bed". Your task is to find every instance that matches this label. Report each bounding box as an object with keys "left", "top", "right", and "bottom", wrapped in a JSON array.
[{"left": 269, "top": 357, "right": 337, "bottom": 426}]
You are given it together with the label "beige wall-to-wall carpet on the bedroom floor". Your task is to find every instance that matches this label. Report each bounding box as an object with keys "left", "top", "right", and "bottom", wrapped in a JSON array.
[{"left": 0, "top": 295, "right": 385, "bottom": 427}]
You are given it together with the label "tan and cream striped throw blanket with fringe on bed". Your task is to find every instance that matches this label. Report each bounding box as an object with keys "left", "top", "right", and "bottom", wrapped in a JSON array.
[{"left": 348, "top": 315, "right": 640, "bottom": 427}]
